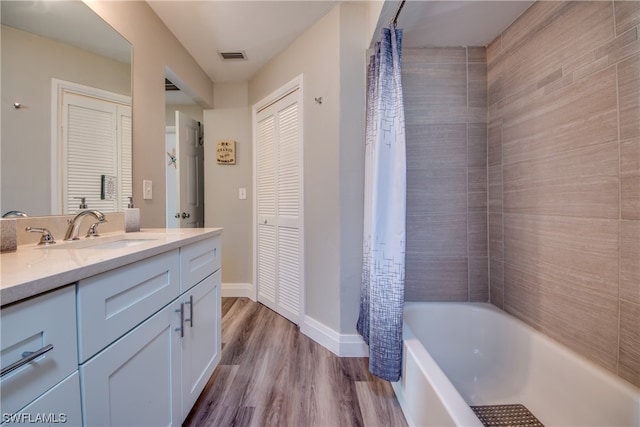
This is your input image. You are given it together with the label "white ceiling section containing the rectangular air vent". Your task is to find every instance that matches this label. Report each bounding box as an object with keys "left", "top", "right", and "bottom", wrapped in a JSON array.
[{"left": 147, "top": 0, "right": 336, "bottom": 82}]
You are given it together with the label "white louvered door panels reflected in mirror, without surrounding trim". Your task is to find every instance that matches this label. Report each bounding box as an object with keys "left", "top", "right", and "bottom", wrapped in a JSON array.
[{"left": 64, "top": 94, "right": 131, "bottom": 213}]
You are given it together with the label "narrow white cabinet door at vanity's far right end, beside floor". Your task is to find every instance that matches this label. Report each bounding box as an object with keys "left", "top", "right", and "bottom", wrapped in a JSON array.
[{"left": 180, "top": 270, "right": 221, "bottom": 420}]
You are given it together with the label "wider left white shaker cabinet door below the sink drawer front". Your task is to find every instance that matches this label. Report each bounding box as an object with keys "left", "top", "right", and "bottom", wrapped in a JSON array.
[{"left": 80, "top": 303, "right": 182, "bottom": 427}]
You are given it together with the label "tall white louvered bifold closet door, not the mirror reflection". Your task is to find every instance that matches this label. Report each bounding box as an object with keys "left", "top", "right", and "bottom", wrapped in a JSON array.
[{"left": 256, "top": 90, "right": 303, "bottom": 324}]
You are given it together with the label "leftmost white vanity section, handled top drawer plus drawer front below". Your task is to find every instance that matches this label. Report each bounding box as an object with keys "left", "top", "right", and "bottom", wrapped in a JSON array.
[{"left": 0, "top": 285, "right": 82, "bottom": 425}]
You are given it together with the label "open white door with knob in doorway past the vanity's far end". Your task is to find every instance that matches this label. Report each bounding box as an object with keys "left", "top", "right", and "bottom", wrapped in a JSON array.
[{"left": 165, "top": 111, "right": 204, "bottom": 228}]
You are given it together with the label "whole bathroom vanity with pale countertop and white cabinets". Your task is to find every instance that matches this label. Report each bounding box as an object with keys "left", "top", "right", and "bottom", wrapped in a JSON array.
[{"left": 0, "top": 228, "right": 222, "bottom": 426}]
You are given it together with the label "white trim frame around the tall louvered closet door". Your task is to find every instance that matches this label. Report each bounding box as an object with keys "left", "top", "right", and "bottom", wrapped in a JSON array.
[{"left": 251, "top": 74, "right": 307, "bottom": 325}]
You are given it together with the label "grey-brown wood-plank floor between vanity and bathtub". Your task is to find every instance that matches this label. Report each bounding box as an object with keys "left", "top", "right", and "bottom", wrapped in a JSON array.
[{"left": 184, "top": 298, "right": 407, "bottom": 427}]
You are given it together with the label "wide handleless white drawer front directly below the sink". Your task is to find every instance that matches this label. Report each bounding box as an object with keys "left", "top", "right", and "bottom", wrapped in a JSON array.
[{"left": 78, "top": 249, "right": 180, "bottom": 363}]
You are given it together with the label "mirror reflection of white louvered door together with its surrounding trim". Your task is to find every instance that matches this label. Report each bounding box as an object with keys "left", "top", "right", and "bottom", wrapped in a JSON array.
[{"left": 56, "top": 80, "right": 132, "bottom": 214}]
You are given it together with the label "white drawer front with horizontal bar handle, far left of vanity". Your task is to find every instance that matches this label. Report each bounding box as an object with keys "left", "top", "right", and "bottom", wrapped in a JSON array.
[{"left": 0, "top": 286, "right": 78, "bottom": 413}]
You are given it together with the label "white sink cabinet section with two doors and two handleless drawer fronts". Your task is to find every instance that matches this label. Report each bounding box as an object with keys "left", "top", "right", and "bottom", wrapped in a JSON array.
[{"left": 78, "top": 236, "right": 221, "bottom": 426}]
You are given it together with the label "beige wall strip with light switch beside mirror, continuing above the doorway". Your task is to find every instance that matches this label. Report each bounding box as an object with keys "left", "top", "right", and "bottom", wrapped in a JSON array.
[{"left": 87, "top": 0, "right": 213, "bottom": 227}]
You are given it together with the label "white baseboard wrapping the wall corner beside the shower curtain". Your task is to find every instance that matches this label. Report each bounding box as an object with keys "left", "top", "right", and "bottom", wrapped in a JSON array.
[{"left": 300, "top": 316, "right": 369, "bottom": 357}]
